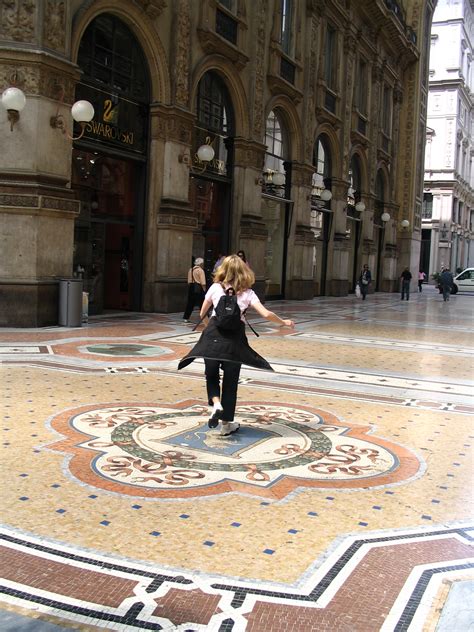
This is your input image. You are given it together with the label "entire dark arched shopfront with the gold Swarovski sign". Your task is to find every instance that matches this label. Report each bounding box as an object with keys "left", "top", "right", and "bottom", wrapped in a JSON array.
[{"left": 72, "top": 13, "right": 149, "bottom": 314}]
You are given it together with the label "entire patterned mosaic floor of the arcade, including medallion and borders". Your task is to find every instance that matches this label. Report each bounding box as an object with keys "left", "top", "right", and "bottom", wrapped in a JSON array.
[{"left": 0, "top": 287, "right": 474, "bottom": 632}]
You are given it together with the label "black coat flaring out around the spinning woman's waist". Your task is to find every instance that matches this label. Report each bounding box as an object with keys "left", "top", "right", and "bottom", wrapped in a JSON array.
[{"left": 178, "top": 318, "right": 273, "bottom": 371}]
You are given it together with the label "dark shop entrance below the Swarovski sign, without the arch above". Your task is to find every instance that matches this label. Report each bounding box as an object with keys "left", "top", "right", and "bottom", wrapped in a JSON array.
[{"left": 72, "top": 149, "right": 143, "bottom": 314}]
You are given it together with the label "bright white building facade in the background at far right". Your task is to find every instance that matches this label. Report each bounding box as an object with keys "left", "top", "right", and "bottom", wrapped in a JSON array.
[{"left": 420, "top": 0, "right": 474, "bottom": 280}]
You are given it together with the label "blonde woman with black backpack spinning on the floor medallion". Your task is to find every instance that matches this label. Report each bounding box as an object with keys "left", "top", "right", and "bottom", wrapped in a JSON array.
[{"left": 178, "top": 255, "right": 295, "bottom": 436}]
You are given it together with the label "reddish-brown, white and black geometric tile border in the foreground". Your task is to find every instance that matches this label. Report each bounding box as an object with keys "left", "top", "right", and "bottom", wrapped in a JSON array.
[{"left": 0, "top": 526, "right": 474, "bottom": 632}]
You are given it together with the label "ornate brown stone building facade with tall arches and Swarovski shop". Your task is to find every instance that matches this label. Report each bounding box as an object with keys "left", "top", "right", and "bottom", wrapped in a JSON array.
[{"left": 0, "top": 0, "right": 434, "bottom": 326}]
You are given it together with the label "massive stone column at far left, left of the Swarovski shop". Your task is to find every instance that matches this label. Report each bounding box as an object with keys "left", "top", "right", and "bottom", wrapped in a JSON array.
[{"left": 0, "top": 0, "right": 79, "bottom": 327}]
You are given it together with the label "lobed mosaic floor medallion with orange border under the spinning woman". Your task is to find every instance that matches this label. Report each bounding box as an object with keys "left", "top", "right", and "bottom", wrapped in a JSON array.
[{"left": 47, "top": 403, "right": 418, "bottom": 497}]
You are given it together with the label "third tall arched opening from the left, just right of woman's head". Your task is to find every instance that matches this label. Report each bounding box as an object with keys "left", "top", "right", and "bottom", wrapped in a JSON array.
[{"left": 261, "top": 110, "right": 293, "bottom": 299}]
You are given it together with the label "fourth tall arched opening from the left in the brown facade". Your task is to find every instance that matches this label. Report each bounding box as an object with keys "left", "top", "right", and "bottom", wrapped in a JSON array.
[{"left": 311, "top": 134, "right": 333, "bottom": 296}]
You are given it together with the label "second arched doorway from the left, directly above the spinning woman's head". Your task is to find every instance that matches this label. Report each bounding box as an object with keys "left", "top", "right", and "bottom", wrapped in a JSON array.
[{"left": 189, "top": 71, "right": 235, "bottom": 282}]
